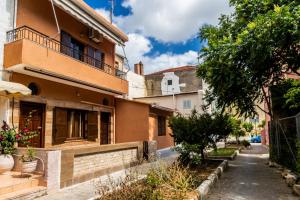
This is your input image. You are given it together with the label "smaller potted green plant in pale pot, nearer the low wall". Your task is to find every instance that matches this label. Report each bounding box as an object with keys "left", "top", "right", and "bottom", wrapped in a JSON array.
[{"left": 21, "top": 146, "right": 38, "bottom": 173}]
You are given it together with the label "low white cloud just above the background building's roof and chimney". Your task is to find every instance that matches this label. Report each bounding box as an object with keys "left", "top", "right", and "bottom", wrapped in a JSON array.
[{"left": 117, "top": 33, "right": 198, "bottom": 73}]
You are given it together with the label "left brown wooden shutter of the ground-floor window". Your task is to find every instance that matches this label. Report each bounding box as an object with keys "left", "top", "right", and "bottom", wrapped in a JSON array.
[{"left": 53, "top": 108, "right": 68, "bottom": 144}]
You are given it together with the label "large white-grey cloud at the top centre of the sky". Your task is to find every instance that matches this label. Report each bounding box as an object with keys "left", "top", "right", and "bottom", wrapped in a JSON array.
[{"left": 115, "top": 0, "right": 231, "bottom": 42}]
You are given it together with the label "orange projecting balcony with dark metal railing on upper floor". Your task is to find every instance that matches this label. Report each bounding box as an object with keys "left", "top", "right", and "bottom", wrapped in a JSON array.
[{"left": 4, "top": 26, "right": 128, "bottom": 94}]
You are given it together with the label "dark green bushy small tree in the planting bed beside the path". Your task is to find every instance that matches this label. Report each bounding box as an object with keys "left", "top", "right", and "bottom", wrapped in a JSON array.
[{"left": 169, "top": 110, "right": 232, "bottom": 163}]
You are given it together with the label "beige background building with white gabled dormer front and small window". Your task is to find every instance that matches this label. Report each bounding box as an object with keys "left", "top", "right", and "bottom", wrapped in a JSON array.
[{"left": 134, "top": 66, "right": 210, "bottom": 115}]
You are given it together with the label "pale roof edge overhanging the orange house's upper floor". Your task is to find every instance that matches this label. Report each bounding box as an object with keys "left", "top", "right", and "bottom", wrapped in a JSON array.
[{"left": 54, "top": 0, "right": 128, "bottom": 42}]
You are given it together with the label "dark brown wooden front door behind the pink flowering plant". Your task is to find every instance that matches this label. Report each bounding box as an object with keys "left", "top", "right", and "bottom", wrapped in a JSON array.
[{"left": 19, "top": 102, "right": 45, "bottom": 148}]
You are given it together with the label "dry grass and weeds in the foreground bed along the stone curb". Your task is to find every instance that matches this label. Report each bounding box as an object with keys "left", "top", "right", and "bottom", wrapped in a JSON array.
[{"left": 98, "top": 161, "right": 220, "bottom": 200}]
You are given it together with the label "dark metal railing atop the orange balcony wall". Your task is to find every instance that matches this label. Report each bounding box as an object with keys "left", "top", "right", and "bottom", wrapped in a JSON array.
[{"left": 6, "top": 26, "right": 125, "bottom": 79}]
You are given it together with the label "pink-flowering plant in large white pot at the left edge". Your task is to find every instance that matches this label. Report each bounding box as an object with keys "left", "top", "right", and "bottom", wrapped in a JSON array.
[{"left": 0, "top": 113, "right": 37, "bottom": 174}]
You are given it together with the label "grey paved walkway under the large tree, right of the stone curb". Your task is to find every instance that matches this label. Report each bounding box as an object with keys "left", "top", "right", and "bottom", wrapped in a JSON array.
[{"left": 208, "top": 144, "right": 300, "bottom": 200}]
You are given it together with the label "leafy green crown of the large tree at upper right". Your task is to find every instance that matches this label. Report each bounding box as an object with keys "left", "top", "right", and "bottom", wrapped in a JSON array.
[{"left": 198, "top": 0, "right": 300, "bottom": 118}]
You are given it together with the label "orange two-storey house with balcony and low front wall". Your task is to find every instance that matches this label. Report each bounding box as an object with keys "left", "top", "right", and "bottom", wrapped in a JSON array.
[{"left": 0, "top": 0, "right": 173, "bottom": 195}]
